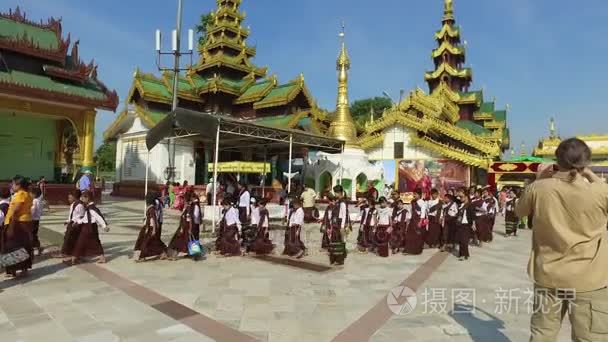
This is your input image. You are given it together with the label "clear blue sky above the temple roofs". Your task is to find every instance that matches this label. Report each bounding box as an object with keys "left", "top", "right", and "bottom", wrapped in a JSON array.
[{"left": 0, "top": 0, "right": 608, "bottom": 166}]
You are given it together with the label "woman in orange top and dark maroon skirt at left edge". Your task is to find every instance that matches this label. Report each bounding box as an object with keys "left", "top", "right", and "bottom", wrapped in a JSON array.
[{"left": 2, "top": 177, "right": 34, "bottom": 278}]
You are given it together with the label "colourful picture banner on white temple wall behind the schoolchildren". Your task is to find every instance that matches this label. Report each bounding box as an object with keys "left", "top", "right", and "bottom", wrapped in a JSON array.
[{"left": 395, "top": 159, "right": 470, "bottom": 197}]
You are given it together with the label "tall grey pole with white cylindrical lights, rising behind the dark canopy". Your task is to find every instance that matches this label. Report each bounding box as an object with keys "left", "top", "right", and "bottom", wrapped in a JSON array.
[{"left": 154, "top": 0, "right": 194, "bottom": 181}]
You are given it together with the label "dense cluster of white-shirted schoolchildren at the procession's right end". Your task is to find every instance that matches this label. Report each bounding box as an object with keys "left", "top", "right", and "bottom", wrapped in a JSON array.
[{"left": 346, "top": 188, "right": 498, "bottom": 260}]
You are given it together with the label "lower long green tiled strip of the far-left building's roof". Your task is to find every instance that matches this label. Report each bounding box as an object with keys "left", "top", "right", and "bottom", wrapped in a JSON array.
[{"left": 0, "top": 71, "right": 107, "bottom": 100}]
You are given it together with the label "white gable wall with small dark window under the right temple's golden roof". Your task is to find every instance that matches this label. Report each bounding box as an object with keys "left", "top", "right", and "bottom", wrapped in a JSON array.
[{"left": 366, "top": 125, "right": 440, "bottom": 160}]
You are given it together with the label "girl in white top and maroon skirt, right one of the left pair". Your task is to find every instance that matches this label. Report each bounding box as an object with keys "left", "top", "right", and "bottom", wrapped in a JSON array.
[{"left": 72, "top": 190, "right": 109, "bottom": 264}]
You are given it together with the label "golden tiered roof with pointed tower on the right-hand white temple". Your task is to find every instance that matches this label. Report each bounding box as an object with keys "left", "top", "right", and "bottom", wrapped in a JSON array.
[{"left": 358, "top": 0, "right": 509, "bottom": 168}]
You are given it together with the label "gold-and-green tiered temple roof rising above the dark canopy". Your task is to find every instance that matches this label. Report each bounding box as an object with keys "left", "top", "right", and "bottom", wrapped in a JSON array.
[{"left": 104, "top": 0, "right": 327, "bottom": 138}]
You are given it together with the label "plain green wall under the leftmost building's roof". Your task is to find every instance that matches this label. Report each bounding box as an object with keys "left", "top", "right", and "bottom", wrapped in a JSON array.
[{"left": 0, "top": 112, "right": 58, "bottom": 181}]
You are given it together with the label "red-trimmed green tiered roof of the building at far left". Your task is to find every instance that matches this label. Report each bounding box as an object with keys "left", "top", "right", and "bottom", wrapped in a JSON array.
[{"left": 0, "top": 7, "right": 118, "bottom": 110}]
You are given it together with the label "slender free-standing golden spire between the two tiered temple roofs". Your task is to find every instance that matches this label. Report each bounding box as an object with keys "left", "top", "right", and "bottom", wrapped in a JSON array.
[{"left": 327, "top": 24, "right": 357, "bottom": 146}]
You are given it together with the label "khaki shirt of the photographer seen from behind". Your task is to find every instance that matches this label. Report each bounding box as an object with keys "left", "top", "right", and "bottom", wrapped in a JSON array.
[{"left": 515, "top": 172, "right": 608, "bottom": 292}]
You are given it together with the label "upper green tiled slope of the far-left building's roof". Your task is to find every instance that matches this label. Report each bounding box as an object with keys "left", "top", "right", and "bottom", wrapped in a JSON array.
[{"left": 0, "top": 18, "right": 59, "bottom": 50}]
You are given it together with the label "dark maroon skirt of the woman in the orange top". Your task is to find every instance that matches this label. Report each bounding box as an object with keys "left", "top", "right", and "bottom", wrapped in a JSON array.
[{"left": 2, "top": 221, "right": 34, "bottom": 274}]
